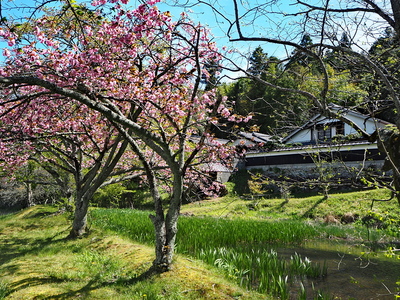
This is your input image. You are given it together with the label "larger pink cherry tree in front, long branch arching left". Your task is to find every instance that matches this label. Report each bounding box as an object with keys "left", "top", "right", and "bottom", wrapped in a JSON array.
[{"left": 0, "top": 0, "right": 242, "bottom": 271}]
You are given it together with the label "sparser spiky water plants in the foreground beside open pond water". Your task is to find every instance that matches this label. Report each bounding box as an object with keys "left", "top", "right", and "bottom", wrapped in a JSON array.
[{"left": 198, "top": 246, "right": 327, "bottom": 299}]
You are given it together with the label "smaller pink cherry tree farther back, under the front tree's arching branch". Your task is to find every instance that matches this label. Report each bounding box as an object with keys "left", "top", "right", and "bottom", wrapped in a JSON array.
[{"left": 0, "top": 89, "right": 142, "bottom": 237}]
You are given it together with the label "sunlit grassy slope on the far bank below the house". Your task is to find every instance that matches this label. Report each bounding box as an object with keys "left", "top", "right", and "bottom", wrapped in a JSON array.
[{"left": 182, "top": 190, "right": 400, "bottom": 220}]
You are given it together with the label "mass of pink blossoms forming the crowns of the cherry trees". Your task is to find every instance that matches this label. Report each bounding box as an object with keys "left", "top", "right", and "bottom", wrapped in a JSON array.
[{"left": 0, "top": 0, "right": 243, "bottom": 196}]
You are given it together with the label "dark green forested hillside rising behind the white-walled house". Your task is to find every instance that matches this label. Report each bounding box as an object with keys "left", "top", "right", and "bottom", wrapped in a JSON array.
[{"left": 220, "top": 27, "right": 399, "bottom": 137}]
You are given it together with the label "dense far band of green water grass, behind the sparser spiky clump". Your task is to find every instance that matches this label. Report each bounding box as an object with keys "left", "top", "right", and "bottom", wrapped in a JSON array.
[{"left": 91, "top": 209, "right": 319, "bottom": 250}]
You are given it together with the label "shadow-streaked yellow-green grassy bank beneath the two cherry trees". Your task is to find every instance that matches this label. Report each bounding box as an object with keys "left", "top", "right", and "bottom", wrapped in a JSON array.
[{"left": 0, "top": 206, "right": 265, "bottom": 300}]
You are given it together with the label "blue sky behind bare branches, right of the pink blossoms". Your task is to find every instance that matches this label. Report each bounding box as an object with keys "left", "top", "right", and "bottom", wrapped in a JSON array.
[{"left": 150, "top": 0, "right": 387, "bottom": 72}]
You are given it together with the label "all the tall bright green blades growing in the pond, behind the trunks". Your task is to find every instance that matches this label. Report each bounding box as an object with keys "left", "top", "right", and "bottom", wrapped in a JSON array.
[{"left": 91, "top": 209, "right": 326, "bottom": 299}]
